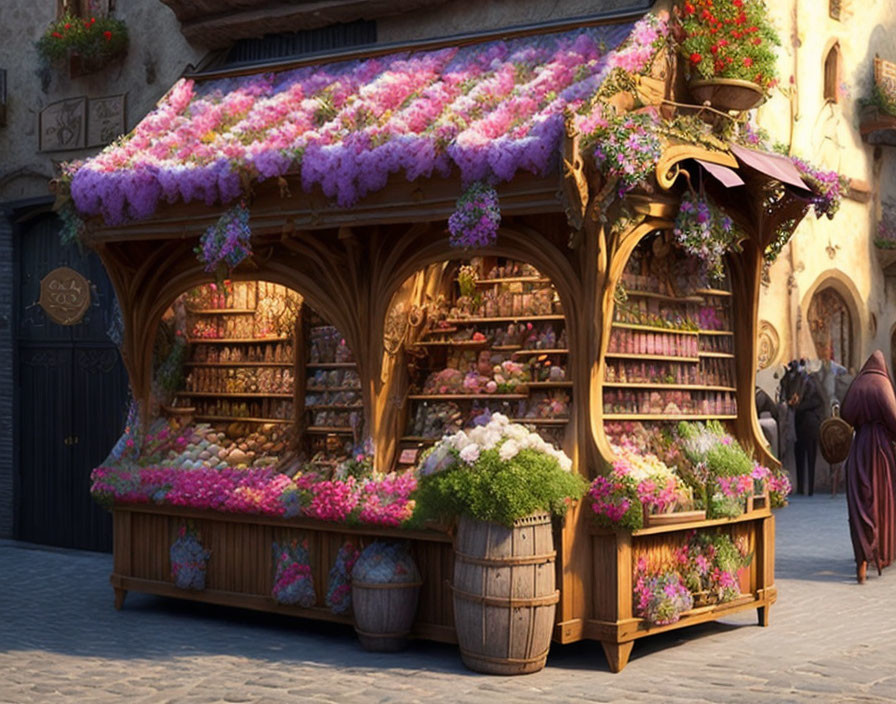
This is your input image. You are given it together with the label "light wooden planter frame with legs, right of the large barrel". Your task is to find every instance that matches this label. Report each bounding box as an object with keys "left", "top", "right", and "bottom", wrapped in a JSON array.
[{"left": 584, "top": 507, "right": 777, "bottom": 672}]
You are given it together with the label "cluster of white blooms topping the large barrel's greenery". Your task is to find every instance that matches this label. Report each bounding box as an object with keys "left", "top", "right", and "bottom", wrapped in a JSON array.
[{"left": 421, "top": 413, "right": 572, "bottom": 475}]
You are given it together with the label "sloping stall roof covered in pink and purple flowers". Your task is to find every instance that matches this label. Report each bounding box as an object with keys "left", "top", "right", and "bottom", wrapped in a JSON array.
[{"left": 64, "top": 20, "right": 665, "bottom": 225}]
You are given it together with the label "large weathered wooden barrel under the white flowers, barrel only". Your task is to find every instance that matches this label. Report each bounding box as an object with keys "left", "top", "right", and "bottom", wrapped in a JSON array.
[{"left": 452, "top": 514, "right": 560, "bottom": 675}]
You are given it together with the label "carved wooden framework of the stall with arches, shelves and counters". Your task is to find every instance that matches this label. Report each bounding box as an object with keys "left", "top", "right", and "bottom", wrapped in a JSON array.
[{"left": 73, "top": 9, "right": 820, "bottom": 672}]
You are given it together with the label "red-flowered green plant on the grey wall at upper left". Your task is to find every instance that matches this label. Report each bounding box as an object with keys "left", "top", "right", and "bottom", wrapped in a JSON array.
[{"left": 37, "top": 15, "right": 129, "bottom": 78}]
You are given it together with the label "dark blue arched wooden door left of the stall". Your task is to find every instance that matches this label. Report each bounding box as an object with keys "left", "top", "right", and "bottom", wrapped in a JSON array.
[{"left": 17, "top": 215, "right": 128, "bottom": 550}]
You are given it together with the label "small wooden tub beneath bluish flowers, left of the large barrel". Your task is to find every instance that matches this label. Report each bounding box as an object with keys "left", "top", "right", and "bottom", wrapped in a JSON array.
[{"left": 352, "top": 581, "right": 422, "bottom": 653}]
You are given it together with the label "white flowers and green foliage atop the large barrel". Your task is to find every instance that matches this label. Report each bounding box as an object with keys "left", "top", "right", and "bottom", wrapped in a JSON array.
[{"left": 413, "top": 413, "right": 586, "bottom": 526}]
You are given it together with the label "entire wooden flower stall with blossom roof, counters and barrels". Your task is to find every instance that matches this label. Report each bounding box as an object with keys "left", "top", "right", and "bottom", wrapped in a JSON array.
[{"left": 59, "top": 5, "right": 838, "bottom": 673}]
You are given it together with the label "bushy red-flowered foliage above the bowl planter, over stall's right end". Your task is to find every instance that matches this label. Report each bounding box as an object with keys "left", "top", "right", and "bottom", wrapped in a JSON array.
[{"left": 675, "top": 0, "right": 781, "bottom": 95}]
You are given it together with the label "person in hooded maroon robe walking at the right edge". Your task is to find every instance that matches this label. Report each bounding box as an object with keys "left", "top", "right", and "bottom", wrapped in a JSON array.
[{"left": 840, "top": 350, "right": 896, "bottom": 583}]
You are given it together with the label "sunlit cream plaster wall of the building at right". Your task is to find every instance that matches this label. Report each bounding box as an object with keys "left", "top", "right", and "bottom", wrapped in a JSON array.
[{"left": 757, "top": 0, "right": 896, "bottom": 392}]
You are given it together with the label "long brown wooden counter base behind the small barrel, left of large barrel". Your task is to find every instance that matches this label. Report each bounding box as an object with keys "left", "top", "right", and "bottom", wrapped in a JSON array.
[{"left": 110, "top": 505, "right": 457, "bottom": 643}]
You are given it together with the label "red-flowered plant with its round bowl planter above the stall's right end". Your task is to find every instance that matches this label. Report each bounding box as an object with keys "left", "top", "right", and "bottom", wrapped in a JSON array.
[{"left": 675, "top": 0, "right": 781, "bottom": 111}]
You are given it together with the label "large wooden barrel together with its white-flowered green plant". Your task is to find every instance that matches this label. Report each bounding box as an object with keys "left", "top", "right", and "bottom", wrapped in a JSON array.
[{"left": 414, "top": 413, "right": 585, "bottom": 675}]
